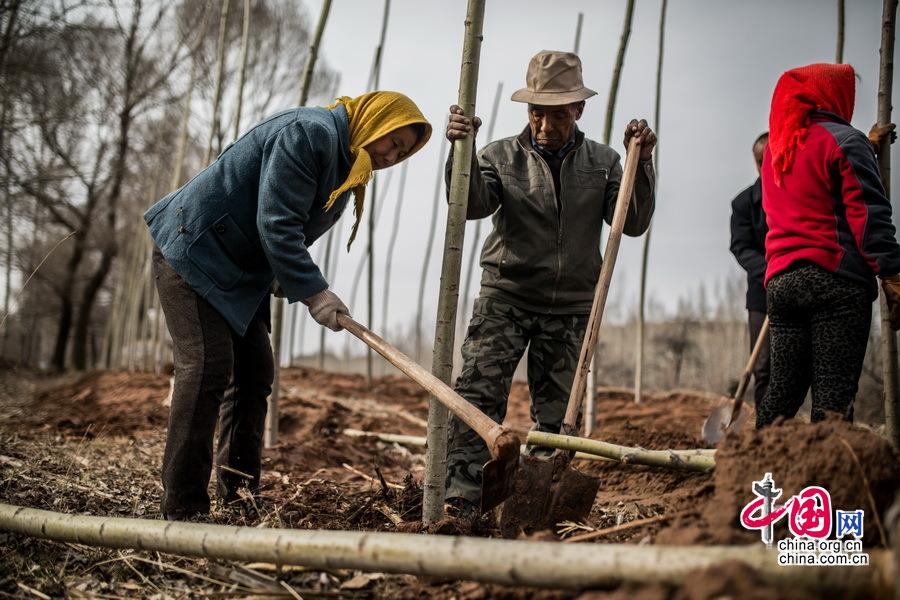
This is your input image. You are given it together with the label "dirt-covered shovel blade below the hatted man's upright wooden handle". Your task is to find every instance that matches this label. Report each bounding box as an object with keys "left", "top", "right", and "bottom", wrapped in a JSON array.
[{"left": 500, "top": 456, "right": 600, "bottom": 538}]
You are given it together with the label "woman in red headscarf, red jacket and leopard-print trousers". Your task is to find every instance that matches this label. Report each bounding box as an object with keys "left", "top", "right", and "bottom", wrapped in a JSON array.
[{"left": 756, "top": 64, "right": 900, "bottom": 428}]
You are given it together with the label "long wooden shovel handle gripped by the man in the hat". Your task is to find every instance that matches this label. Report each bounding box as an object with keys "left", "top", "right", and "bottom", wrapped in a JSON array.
[{"left": 562, "top": 137, "right": 640, "bottom": 426}]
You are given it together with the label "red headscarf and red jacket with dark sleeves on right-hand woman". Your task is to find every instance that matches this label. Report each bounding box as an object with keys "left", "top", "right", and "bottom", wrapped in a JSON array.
[{"left": 762, "top": 65, "right": 900, "bottom": 298}]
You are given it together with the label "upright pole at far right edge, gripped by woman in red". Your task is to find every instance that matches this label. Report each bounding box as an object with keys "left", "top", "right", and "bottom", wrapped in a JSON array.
[{"left": 878, "top": 0, "right": 900, "bottom": 451}]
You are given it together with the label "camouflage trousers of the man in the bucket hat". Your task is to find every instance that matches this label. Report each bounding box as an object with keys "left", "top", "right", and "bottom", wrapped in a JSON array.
[{"left": 445, "top": 297, "right": 588, "bottom": 503}]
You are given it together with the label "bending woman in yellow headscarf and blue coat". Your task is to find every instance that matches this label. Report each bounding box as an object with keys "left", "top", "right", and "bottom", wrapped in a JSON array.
[{"left": 144, "top": 92, "right": 431, "bottom": 520}]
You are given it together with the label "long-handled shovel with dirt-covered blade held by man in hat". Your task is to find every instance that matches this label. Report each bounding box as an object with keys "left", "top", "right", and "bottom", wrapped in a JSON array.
[{"left": 500, "top": 138, "right": 640, "bottom": 537}]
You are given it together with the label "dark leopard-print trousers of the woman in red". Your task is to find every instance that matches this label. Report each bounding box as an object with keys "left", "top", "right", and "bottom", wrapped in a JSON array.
[{"left": 756, "top": 263, "right": 872, "bottom": 429}]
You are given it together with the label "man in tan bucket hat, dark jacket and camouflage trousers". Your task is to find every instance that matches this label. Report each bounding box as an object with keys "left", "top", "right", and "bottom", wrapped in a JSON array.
[{"left": 446, "top": 51, "right": 656, "bottom": 517}]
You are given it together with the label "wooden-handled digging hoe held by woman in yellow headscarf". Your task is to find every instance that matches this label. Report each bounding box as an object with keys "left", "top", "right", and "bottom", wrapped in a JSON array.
[{"left": 337, "top": 313, "right": 522, "bottom": 513}]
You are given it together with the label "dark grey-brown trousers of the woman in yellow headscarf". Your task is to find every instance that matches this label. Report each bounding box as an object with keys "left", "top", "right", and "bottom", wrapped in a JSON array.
[{"left": 153, "top": 249, "right": 275, "bottom": 514}]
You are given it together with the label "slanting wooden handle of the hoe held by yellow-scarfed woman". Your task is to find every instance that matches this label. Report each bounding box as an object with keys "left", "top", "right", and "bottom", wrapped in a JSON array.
[{"left": 337, "top": 313, "right": 506, "bottom": 448}]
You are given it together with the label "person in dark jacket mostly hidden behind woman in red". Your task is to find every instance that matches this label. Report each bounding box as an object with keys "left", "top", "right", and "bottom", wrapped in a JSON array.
[{"left": 731, "top": 132, "right": 769, "bottom": 405}]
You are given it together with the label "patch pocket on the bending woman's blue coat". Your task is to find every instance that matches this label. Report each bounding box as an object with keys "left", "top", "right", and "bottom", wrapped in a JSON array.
[{"left": 187, "top": 214, "right": 252, "bottom": 290}]
